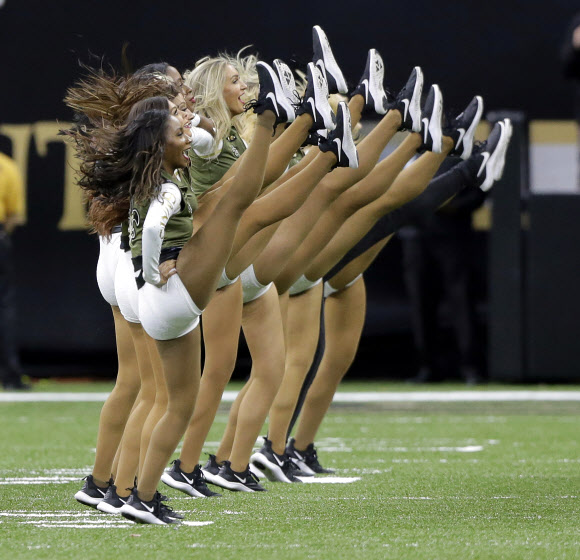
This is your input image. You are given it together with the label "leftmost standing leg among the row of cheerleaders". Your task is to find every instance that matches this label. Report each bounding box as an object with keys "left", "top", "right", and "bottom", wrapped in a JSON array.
[{"left": 93, "top": 307, "right": 140, "bottom": 487}]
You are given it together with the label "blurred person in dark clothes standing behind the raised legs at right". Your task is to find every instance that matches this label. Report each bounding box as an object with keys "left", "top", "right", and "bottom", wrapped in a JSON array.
[{"left": 400, "top": 158, "right": 486, "bottom": 384}]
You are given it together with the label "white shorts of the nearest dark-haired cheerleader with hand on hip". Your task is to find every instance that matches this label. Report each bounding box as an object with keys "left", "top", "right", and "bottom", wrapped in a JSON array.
[{"left": 138, "top": 274, "right": 201, "bottom": 340}]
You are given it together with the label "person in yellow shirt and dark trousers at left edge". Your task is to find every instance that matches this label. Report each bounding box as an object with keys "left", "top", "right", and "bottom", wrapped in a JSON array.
[{"left": 0, "top": 153, "right": 30, "bottom": 390}]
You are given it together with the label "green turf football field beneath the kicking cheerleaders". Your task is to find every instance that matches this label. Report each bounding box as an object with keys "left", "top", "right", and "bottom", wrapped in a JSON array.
[{"left": 0, "top": 383, "right": 580, "bottom": 560}]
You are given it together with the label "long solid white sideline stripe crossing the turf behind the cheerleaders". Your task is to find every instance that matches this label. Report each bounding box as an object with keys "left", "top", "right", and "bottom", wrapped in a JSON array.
[{"left": 0, "top": 390, "right": 580, "bottom": 403}]
